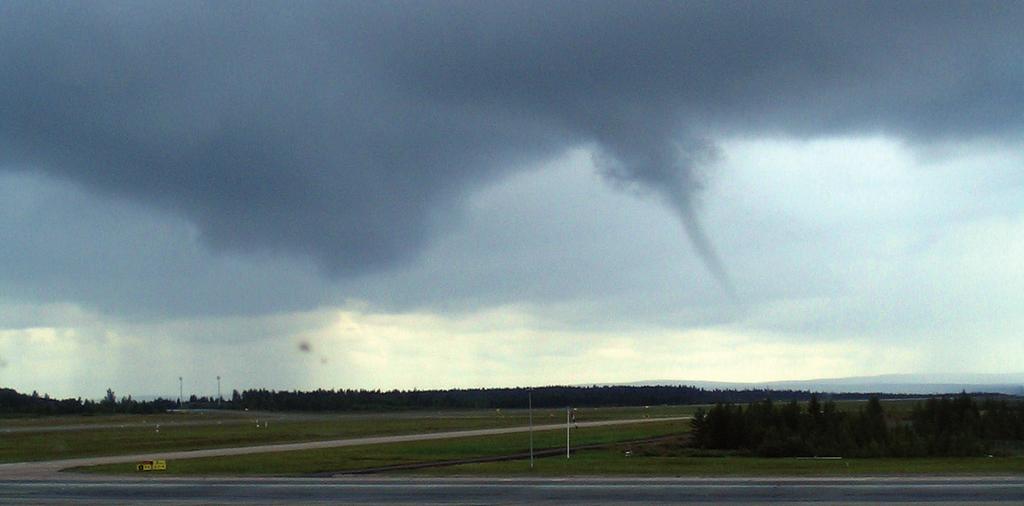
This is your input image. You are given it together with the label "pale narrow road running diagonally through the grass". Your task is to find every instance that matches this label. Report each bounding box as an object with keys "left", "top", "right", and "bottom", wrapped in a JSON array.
[{"left": 0, "top": 417, "right": 691, "bottom": 480}]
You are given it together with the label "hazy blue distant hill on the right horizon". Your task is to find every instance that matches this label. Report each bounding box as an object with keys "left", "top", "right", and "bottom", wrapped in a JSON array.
[{"left": 616, "top": 373, "right": 1024, "bottom": 395}]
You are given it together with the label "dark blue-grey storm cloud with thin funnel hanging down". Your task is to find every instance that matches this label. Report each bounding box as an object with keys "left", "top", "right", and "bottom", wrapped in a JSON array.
[{"left": 0, "top": 1, "right": 1024, "bottom": 283}]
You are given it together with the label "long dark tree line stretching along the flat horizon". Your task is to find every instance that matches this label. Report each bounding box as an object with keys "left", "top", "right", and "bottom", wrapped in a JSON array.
[{"left": 0, "top": 385, "right": 921, "bottom": 415}]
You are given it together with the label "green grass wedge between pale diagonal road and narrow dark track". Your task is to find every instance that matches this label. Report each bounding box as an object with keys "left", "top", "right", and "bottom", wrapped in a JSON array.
[{"left": 75, "top": 421, "right": 689, "bottom": 475}]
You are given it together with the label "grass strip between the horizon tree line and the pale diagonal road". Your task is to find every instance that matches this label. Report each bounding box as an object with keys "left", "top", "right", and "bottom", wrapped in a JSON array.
[{"left": 0, "top": 407, "right": 693, "bottom": 462}]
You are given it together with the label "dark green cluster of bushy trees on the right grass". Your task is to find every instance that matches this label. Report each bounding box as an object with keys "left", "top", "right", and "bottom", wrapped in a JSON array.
[{"left": 691, "top": 393, "right": 1024, "bottom": 457}]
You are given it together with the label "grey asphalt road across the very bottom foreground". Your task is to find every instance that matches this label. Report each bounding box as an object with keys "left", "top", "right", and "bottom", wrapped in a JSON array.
[{"left": 0, "top": 477, "right": 1024, "bottom": 504}]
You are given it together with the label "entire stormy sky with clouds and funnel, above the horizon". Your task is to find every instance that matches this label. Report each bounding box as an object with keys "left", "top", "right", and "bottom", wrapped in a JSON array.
[{"left": 0, "top": 0, "right": 1024, "bottom": 397}]
